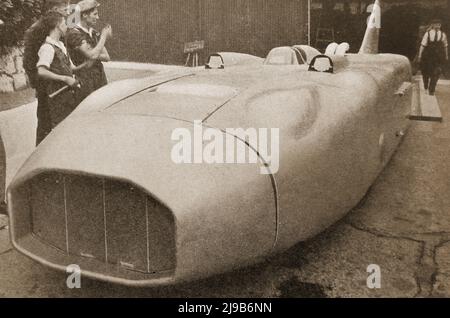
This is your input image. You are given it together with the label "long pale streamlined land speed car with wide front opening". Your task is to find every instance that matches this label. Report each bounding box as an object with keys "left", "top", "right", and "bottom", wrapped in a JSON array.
[{"left": 8, "top": 0, "right": 413, "bottom": 286}]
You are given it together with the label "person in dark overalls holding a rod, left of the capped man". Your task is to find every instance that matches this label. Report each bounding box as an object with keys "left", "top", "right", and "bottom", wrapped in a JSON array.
[{"left": 24, "top": 12, "right": 85, "bottom": 145}]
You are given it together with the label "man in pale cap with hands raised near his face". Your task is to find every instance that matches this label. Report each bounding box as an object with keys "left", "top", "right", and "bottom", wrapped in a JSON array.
[{"left": 66, "top": 0, "right": 112, "bottom": 102}]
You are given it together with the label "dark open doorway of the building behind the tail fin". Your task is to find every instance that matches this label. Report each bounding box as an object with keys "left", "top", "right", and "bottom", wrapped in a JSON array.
[{"left": 311, "top": 0, "right": 450, "bottom": 59}]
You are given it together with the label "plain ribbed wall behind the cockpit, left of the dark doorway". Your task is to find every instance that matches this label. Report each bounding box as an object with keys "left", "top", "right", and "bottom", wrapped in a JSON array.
[{"left": 100, "top": 0, "right": 308, "bottom": 64}]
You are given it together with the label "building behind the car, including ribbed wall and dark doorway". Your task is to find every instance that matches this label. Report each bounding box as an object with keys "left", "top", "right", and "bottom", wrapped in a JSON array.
[{"left": 100, "top": 0, "right": 450, "bottom": 64}]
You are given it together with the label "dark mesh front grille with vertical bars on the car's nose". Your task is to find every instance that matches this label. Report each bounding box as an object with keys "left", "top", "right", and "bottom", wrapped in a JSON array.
[{"left": 29, "top": 172, "right": 175, "bottom": 274}]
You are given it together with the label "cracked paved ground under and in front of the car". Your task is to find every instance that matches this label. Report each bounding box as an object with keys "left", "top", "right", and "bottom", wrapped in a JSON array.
[{"left": 0, "top": 71, "right": 450, "bottom": 298}]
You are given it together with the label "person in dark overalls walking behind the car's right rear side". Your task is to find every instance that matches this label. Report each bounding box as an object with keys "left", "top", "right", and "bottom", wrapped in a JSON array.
[{"left": 419, "top": 19, "right": 448, "bottom": 95}]
